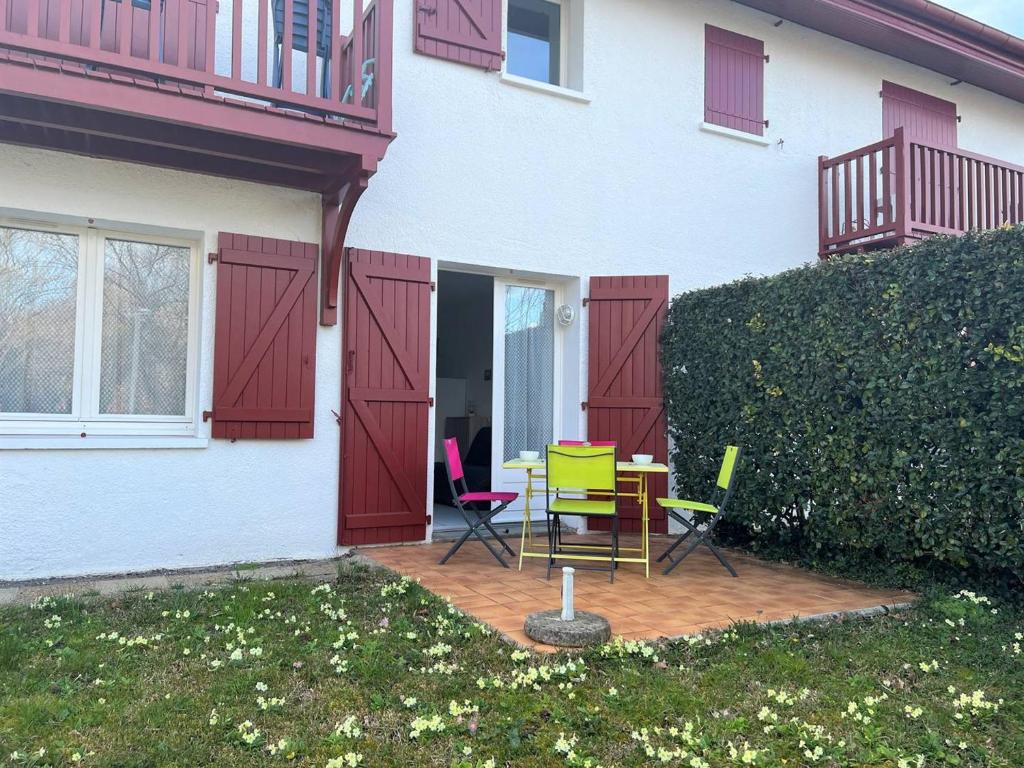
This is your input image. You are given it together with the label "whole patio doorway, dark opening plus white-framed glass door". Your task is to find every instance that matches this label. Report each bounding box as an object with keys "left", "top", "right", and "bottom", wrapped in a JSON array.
[{"left": 432, "top": 269, "right": 575, "bottom": 534}]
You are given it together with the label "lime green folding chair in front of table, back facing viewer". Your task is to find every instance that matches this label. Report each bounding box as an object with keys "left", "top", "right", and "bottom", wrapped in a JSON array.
[{"left": 545, "top": 445, "right": 618, "bottom": 582}]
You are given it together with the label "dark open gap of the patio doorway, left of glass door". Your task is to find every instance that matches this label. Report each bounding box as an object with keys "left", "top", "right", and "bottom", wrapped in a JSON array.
[{"left": 433, "top": 270, "right": 495, "bottom": 532}]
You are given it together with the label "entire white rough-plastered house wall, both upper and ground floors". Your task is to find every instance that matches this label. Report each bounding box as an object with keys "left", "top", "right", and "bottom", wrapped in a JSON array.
[{"left": 0, "top": 0, "right": 1024, "bottom": 580}]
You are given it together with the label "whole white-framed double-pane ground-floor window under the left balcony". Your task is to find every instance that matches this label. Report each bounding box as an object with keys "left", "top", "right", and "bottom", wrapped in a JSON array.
[{"left": 0, "top": 222, "right": 199, "bottom": 435}]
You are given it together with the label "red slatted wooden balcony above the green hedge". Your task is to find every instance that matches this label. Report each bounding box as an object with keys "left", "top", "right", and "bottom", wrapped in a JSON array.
[{"left": 818, "top": 128, "right": 1024, "bottom": 258}]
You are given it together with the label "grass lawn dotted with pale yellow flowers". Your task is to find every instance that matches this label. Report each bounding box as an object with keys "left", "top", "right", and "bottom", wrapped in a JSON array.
[{"left": 0, "top": 566, "right": 1024, "bottom": 768}]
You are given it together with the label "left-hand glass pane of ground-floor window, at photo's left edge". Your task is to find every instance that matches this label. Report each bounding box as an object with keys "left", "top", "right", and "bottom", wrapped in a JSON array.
[{"left": 0, "top": 226, "right": 79, "bottom": 414}]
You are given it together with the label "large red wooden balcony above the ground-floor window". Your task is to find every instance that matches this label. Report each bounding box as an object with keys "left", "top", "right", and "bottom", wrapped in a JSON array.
[{"left": 0, "top": 0, "right": 393, "bottom": 192}]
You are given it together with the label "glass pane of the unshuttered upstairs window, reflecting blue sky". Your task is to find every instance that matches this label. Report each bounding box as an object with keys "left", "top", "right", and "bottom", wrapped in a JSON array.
[{"left": 507, "top": 0, "right": 561, "bottom": 85}]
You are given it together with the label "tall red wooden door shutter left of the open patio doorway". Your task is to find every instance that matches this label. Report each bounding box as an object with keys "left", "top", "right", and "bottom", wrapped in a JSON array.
[{"left": 338, "top": 248, "right": 430, "bottom": 545}]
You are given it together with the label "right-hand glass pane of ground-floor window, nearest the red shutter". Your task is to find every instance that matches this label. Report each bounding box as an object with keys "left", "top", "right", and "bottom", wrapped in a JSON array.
[{"left": 99, "top": 240, "right": 189, "bottom": 416}]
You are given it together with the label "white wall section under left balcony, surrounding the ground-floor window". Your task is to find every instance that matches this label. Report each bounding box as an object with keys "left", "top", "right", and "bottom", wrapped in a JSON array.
[{"left": 0, "top": 153, "right": 340, "bottom": 580}]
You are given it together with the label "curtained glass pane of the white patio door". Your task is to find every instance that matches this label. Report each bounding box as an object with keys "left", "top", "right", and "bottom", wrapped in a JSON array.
[{"left": 505, "top": 286, "right": 555, "bottom": 460}]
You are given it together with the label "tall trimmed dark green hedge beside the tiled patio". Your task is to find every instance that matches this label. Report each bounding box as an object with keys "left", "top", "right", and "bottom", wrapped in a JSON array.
[{"left": 662, "top": 227, "right": 1024, "bottom": 590}]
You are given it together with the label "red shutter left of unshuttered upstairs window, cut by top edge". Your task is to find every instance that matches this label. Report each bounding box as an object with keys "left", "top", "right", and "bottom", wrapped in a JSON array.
[{"left": 413, "top": 0, "right": 502, "bottom": 70}]
